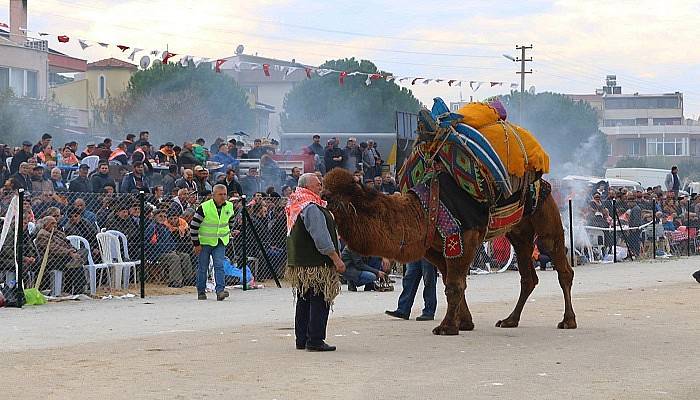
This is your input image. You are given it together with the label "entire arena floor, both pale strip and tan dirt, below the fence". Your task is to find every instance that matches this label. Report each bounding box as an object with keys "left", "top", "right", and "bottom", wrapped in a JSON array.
[{"left": 0, "top": 258, "right": 700, "bottom": 399}]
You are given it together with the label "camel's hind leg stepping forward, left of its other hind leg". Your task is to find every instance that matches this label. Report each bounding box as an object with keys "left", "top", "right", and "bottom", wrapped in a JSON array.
[{"left": 496, "top": 218, "right": 538, "bottom": 328}]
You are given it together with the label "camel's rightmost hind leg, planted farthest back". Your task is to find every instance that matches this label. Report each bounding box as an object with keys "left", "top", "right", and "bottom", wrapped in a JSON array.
[{"left": 532, "top": 195, "right": 576, "bottom": 329}]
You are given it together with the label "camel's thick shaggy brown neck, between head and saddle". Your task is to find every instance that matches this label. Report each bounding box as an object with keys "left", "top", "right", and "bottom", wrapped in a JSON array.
[{"left": 336, "top": 195, "right": 428, "bottom": 262}]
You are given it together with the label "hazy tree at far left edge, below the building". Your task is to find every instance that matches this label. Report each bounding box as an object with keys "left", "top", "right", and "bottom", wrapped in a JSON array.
[{"left": 0, "top": 90, "right": 66, "bottom": 146}]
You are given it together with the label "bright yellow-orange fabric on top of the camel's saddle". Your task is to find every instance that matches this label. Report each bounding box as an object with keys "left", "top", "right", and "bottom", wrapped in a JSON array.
[{"left": 457, "top": 103, "right": 549, "bottom": 177}]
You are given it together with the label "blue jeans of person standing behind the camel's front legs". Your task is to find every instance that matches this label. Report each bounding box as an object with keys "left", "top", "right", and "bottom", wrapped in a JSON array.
[{"left": 396, "top": 259, "right": 437, "bottom": 317}]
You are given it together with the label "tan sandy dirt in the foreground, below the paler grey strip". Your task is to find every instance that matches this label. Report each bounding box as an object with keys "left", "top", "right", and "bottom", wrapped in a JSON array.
[{"left": 0, "top": 260, "right": 700, "bottom": 399}]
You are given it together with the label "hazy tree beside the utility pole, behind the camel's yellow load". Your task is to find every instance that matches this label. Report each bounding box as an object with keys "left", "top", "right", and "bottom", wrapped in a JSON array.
[{"left": 500, "top": 92, "right": 607, "bottom": 176}]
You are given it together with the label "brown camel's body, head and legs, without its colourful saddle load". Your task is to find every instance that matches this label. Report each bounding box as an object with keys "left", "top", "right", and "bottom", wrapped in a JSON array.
[{"left": 323, "top": 168, "right": 576, "bottom": 335}]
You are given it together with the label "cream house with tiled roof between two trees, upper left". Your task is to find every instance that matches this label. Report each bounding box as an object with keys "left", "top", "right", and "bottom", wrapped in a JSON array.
[{"left": 50, "top": 58, "right": 137, "bottom": 134}]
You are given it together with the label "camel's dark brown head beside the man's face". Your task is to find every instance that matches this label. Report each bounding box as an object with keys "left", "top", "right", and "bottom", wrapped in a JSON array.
[{"left": 323, "top": 168, "right": 381, "bottom": 213}]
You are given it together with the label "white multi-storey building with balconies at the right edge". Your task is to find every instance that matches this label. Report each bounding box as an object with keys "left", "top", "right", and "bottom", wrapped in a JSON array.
[{"left": 568, "top": 75, "right": 700, "bottom": 166}]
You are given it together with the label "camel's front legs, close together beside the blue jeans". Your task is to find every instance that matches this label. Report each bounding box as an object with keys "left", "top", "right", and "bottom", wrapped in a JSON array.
[{"left": 426, "top": 230, "right": 481, "bottom": 335}]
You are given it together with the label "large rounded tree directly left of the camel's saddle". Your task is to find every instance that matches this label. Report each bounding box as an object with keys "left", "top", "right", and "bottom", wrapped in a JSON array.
[{"left": 280, "top": 58, "right": 420, "bottom": 132}]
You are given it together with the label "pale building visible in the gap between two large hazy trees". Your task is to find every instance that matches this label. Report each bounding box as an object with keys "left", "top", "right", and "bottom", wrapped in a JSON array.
[{"left": 221, "top": 52, "right": 306, "bottom": 139}]
